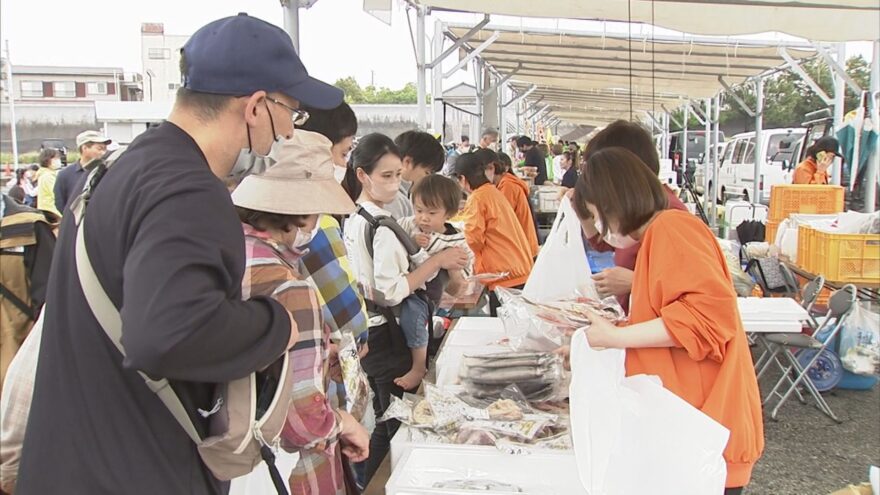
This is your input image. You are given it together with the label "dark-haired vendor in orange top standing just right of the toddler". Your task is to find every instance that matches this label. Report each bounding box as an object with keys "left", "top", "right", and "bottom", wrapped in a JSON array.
[{"left": 454, "top": 153, "right": 534, "bottom": 316}]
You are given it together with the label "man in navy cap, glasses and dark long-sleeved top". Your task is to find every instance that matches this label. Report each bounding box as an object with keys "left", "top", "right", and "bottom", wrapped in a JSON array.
[{"left": 16, "top": 14, "right": 343, "bottom": 495}]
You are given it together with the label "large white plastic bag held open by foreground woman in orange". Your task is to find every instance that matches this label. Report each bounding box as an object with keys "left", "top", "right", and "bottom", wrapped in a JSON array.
[{"left": 570, "top": 331, "right": 730, "bottom": 495}]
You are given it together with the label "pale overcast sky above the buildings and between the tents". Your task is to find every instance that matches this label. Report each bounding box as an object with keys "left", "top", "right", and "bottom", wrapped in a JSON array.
[{"left": 0, "top": 0, "right": 871, "bottom": 88}]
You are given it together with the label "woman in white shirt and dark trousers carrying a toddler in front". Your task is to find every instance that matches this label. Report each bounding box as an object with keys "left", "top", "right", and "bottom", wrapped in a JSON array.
[{"left": 342, "top": 134, "right": 468, "bottom": 483}]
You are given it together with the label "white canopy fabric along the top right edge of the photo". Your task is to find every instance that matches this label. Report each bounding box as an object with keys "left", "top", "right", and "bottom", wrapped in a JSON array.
[{"left": 413, "top": 0, "right": 880, "bottom": 41}]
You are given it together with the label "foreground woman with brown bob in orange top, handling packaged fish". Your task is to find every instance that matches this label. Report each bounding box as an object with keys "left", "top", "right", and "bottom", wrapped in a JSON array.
[{"left": 574, "top": 147, "right": 764, "bottom": 494}]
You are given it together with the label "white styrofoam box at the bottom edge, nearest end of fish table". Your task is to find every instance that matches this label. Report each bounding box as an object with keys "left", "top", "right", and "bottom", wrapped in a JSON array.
[{"left": 385, "top": 448, "right": 586, "bottom": 495}]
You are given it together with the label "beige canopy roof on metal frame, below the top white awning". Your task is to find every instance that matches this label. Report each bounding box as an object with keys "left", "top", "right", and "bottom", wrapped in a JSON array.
[{"left": 448, "top": 24, "right": 816, "bottom": 124}]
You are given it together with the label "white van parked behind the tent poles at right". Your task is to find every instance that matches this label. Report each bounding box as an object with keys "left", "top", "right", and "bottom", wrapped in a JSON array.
[{"left": 718, "top": 128, "right": 807, "bottom": 204}]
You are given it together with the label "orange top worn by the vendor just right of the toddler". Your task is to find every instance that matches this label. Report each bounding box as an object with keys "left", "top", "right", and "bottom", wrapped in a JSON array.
[{"left": 462, "top": 183, "right": 534, "bottom": 290}]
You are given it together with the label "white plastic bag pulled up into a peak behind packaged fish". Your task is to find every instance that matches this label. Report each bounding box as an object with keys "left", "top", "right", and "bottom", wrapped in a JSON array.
[{"left": 523, "top": 197, "right": 599, "bottom": 302}]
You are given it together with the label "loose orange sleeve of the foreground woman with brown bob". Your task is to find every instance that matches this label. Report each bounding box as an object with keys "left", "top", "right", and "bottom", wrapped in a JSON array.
[{"left": 643, "top": 226, "right": 739, "bottom": 362}]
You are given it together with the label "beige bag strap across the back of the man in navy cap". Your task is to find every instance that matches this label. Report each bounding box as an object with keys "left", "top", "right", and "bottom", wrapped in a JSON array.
[{"left": 71, "top": 148, "right": 202, "bottom": 444}]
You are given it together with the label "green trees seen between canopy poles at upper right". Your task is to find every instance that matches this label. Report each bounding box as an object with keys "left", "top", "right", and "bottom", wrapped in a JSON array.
[{"left": 674, "top": 55, "right": 871, "bottom": 129}]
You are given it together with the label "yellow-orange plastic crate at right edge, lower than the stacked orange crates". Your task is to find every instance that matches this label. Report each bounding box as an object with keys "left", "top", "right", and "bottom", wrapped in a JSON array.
[{"left": 798, "top": 229, "right": 880, "bottom": 284}]
